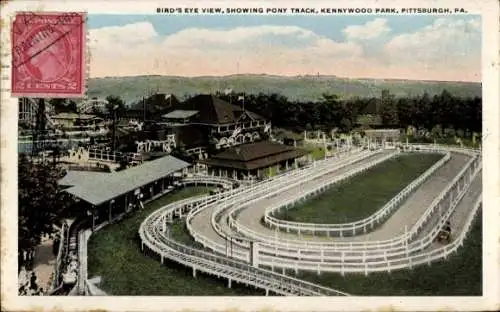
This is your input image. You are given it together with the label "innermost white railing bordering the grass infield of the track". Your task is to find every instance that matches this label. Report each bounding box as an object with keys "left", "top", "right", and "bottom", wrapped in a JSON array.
[{"left": 264, "top": 153, "right": 451, "bottom": 237}]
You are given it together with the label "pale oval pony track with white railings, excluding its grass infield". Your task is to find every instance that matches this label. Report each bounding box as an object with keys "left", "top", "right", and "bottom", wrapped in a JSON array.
[{"left": 139, "top": 144, "right": 482, "bottom": 296}]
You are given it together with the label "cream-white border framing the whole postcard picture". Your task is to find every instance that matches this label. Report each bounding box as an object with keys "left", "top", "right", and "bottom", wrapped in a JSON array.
[{"left": 1, "top": 0, "right": 500, "bottom": 311}]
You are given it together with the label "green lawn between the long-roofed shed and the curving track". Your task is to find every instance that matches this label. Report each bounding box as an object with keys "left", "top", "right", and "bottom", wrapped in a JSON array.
[{"left": 88, "top": 187, "right": 264, "bottom": 296}]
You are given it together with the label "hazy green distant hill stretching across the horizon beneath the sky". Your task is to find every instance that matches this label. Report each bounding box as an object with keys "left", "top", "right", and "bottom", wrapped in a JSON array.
[{"left": 88, "top": 75, "right": 481, "bottom": 104}]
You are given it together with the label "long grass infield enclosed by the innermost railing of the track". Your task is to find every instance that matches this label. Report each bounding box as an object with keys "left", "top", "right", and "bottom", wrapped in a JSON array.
[{"left": 276, "top": 153, "right": 443, "bottom": 223}]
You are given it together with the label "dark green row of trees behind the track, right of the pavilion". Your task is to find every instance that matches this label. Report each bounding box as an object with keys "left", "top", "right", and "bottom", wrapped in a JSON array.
[{"left": 217, "top": 90, "right": 482, "bottom": 137}]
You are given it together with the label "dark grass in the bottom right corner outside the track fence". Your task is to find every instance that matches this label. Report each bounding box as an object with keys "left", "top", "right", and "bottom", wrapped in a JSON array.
[{"left": 297, "top": 213, "right": 483, "bottom": 296}]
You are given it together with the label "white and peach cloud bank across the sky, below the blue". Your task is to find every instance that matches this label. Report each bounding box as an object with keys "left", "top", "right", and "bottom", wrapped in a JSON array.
[{"left": 90, "top": 19, "right": 480, "bottom": 80}]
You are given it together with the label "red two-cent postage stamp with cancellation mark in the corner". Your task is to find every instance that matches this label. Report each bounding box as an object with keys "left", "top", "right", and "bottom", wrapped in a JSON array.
[{"left": 12, "top": 12, "right": 86, "bottom": 98}]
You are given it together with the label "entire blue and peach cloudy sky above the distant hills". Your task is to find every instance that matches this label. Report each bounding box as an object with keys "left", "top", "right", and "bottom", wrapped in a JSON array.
[{"left": 88, "top": 14, "right": 481, "bottom": 81}]
